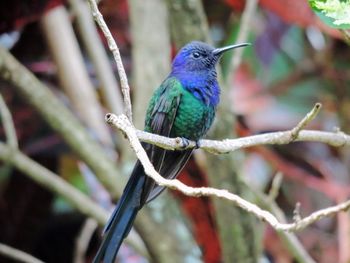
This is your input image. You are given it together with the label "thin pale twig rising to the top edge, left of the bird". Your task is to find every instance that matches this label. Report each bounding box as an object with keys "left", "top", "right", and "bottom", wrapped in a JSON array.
[{"left": 89, "top": 0, "right": 132, "bottom": 122}]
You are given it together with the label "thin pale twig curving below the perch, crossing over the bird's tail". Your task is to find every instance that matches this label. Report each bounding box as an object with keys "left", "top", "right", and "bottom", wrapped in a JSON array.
[{"left": 107, "top": 115, "right": 350, "bottom": 231}]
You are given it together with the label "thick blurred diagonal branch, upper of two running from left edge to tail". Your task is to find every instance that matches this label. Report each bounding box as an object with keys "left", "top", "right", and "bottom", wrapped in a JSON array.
[{"left": 0, "top": 47, "right": 122, "bottom": 196}]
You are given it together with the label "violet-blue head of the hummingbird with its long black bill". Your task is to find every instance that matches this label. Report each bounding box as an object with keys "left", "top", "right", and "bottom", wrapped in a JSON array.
[{"left": 172, "top": 41, "right": 250, "bottom": 73}]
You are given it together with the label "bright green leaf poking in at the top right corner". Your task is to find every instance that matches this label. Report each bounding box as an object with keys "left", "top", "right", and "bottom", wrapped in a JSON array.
[{"left": 309, "top": 0, "right": 350, "bottom": 29}]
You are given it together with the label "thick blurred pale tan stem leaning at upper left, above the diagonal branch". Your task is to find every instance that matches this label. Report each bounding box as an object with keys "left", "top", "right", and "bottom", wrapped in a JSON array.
[{"left": 41, "top": 6, "right": 113, "bottom": 148}]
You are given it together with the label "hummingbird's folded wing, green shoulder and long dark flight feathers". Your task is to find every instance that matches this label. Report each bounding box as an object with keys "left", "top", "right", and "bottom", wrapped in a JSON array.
[{"left": 144, "top": 78, "right": 192, "bottom": 205}]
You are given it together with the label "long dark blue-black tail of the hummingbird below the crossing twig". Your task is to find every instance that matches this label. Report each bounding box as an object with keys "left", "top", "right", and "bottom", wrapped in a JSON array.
[{"left": 93, "top": 164, "right": 146, "bottom": 263}]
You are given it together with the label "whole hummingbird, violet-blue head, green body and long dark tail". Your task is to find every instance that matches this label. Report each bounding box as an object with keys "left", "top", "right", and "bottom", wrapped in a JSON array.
[{"left": 93, "top": 41, "right": 250, "bottom": 263}]
